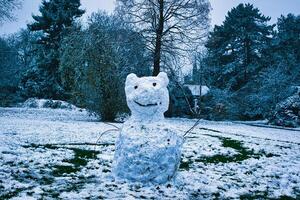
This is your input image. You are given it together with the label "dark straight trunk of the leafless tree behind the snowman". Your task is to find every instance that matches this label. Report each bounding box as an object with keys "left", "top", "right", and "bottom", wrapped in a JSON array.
[{"left": 153, "top": 0, "right": 164, "bottom": 76}]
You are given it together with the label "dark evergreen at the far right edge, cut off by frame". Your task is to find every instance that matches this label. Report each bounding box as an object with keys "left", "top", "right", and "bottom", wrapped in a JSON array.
[{"left": 256, "top": 14, "right": 300, "bottom": 118}]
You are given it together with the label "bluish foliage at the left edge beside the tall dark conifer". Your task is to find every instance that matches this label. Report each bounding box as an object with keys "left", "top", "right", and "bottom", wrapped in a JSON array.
[{"left": 0, "top": 29, "right": 44, "bottom": 106}]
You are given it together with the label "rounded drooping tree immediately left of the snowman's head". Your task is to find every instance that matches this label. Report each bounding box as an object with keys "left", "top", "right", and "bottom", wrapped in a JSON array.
[{"left": 60, "top": 13, "right": 149, "bottom": 121}]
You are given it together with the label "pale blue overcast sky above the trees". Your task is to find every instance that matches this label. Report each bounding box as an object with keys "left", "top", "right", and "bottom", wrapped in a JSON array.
[{"left": 0, "top": 0, "right": 300, "bottom": 35}]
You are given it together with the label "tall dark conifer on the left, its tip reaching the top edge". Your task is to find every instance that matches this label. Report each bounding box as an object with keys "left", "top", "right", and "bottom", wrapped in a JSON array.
[{"left": 23, "top": 0, "right": 84, "bottom": 99}]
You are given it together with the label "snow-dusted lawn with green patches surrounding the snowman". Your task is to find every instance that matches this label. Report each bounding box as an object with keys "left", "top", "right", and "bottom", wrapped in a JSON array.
[{"left": 0, "top": 108, "right": 300, "bottom": 199}]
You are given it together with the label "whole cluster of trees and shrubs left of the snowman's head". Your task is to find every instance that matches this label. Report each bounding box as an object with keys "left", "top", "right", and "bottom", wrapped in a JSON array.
[{"left": 0, "top": 0, "right": 150, "bottom": 120}]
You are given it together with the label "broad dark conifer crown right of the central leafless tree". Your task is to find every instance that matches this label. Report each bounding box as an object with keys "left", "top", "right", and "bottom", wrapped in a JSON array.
[{"left": 206, "top": 4, "right": 273, "bottom": 91}]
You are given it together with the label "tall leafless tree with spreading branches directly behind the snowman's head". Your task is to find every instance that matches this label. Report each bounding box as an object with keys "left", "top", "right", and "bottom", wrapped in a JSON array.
[{"left": 117, "top": 0, "right": 211, "bottom": 76}]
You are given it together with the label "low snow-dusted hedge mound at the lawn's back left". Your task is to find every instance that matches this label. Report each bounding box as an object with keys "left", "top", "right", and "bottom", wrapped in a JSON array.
[{"left": 21, "top": 98, "right": 82, "bottom": 110}]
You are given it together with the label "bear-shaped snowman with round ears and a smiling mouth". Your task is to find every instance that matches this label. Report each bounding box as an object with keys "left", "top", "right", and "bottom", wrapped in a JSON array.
[{"left": 113, "top": 72, "right": 183, "bottom": 183}]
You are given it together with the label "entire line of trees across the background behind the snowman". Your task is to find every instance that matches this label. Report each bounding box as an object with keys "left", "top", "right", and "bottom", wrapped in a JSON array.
[{"left": 0, "top": 0, "right": 300, "bottom": 120}]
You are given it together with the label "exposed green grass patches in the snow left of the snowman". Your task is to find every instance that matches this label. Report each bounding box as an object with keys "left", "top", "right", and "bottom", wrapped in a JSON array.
[{"left": 17, "top": 144, "right": 101, "bottom": 199}]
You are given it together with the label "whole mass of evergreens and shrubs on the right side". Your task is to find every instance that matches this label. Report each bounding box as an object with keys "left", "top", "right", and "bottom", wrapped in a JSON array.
[{"left": 204, "top": 4, "right": 300, "bottom": 120}]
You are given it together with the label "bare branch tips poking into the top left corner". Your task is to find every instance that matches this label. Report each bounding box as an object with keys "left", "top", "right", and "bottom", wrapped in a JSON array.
[{"left": 0, "top": 0, "right": 23, "bottom": 25}]
